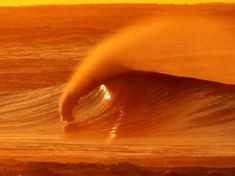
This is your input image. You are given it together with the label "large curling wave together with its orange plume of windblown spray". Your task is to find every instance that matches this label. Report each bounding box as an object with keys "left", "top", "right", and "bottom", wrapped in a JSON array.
[{"left": 59, "top": 14, "right": 235, "bottom": 142}]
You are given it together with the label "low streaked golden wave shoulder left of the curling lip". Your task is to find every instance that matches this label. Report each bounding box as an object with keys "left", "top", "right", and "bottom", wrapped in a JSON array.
[{"left": 0, "top": 85, "right": 64, "bottom": 132}]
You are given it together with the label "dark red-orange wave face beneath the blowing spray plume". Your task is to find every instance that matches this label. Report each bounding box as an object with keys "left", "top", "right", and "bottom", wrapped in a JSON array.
[{"left": 65, "top": 72, "right": 235, "bottom": 140}]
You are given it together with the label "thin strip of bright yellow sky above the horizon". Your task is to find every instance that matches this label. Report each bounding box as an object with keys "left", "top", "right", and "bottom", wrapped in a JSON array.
[{"left": 0, "top": 0, "right": 235, "bottom": 6}]
